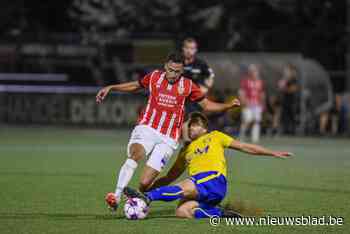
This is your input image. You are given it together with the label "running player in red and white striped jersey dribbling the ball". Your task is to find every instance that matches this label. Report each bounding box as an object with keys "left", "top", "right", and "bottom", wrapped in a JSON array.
[{"left": 96, "top": 53, "right": 240, "bottom": 210}]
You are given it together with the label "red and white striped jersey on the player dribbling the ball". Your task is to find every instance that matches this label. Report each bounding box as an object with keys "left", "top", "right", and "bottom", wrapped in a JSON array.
[{"left": 138, "top": 70, "right": 205, "bottom": 141}]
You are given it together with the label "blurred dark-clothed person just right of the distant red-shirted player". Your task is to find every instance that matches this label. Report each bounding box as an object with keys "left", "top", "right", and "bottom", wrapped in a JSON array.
[{"left": 278, "top": 64, "right": 300, "bottom": 134}]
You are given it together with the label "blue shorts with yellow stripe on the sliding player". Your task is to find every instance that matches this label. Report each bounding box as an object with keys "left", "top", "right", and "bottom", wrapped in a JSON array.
[{"left": 191, "top": 171, "right": 227, "bottom": 206}]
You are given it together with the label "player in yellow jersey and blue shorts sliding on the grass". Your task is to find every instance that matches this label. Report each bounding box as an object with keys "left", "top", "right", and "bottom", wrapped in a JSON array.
[{"left": 124, "top": 112, "right": 292, "bottom": 218}]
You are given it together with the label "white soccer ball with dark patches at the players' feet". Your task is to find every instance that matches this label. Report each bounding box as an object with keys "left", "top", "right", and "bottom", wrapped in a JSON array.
[{"left": 124, "top": 198, "right": 149, "bottom": 220}]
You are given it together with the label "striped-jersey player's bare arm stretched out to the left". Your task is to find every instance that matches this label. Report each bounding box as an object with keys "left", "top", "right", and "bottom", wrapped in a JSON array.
[{"left": 96, "top": 81, "right": 142, "bottom": 103}]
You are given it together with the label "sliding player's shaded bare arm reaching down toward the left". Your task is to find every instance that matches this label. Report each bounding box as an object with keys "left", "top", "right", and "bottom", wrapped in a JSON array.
[{"left": 149, "top": 155, "right": 186, "bottom": 190}]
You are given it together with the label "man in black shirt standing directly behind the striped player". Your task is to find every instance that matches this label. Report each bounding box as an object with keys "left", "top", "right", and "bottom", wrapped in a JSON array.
[{"left": 182, "top": 38, "right": 214, "bottom": 113}]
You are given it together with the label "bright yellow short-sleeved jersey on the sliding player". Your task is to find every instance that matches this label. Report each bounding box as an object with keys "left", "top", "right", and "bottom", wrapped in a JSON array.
[{"left": 178, "top": 131, "right": 234, "bottom": 177}]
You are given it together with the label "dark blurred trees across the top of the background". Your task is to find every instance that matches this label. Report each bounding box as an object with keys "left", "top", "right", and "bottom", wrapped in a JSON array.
[{"left": 0, "top": 0, "right": 347, "bottom": 69}]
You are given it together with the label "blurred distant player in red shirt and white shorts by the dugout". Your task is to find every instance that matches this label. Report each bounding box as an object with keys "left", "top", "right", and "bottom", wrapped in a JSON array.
[{"left": 239, "top": 64, "right": 265, "bottom": 143}]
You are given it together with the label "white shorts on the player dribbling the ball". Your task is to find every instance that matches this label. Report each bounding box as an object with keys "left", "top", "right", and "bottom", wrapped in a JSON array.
[{"left": 128, "top": 125, "right": 178, "bottom": 172}]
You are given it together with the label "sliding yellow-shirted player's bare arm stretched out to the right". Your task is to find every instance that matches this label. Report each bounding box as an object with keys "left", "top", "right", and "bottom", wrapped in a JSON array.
[{"left": 229, "top": 140, "right": 293, "bottom": 158}]
